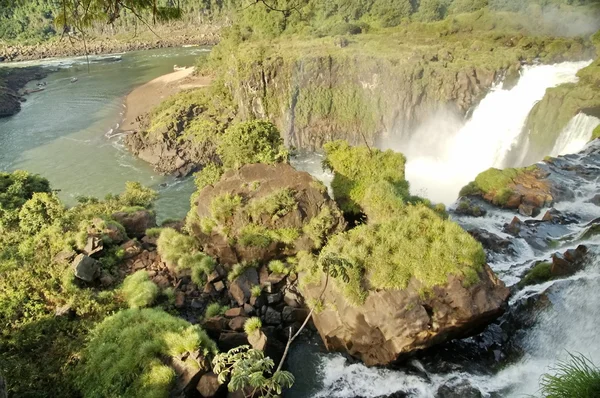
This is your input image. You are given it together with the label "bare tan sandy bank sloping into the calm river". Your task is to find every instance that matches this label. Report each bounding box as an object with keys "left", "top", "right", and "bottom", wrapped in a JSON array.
[{"left": 121, "top": 68, "right": 212, "bottom": 131}]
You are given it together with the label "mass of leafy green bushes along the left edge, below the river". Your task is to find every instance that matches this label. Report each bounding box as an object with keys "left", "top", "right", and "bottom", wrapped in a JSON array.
[{"left": 0, "top": 171, "right": 164, "bottom": 397}]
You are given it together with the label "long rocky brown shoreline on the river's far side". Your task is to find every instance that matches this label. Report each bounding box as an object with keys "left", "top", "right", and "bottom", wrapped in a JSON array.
[{"left": 0, "top": 25, "right": 221, "bottom": 62}]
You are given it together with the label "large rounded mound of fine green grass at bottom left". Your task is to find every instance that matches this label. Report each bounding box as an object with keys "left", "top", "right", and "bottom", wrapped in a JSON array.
[{"left": 76, "top": 309, "right": 217, "bottom": 398}]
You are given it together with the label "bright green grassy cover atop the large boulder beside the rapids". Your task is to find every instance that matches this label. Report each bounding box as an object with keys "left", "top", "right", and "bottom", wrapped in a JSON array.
[{"left": 312, "top": 204, "right": 485, "bottom": 305}]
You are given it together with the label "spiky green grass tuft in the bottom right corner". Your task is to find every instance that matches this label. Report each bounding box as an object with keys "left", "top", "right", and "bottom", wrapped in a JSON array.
[{"left": 540, "top": 354, "right": 600, "bottom": 398}]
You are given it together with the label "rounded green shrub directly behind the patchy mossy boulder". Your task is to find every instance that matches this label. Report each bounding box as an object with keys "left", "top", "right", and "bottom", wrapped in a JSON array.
[{"left": 217, "top": 120, "right": 289, "bottom": 169}]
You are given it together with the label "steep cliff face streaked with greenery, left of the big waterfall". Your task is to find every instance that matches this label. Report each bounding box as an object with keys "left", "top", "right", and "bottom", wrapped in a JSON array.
[{"left": 229, "top": 53, "right": 502, "bottom": 150}]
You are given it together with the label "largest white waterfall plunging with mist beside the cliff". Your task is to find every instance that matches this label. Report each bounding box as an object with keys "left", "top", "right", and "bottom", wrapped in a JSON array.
[{"left": 382, "top": 62, "right": 589, "bottom": 204}]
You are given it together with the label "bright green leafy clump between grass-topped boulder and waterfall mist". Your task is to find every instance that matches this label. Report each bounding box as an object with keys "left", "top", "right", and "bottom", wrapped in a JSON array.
[{"left": 324, "top": 141, "right": 408, "bottom": 214}]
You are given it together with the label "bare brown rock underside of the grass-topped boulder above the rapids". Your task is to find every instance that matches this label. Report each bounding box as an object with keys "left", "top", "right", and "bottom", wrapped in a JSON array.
[{"left": 302, "top": 265, "right": 509, "bottom": 365}]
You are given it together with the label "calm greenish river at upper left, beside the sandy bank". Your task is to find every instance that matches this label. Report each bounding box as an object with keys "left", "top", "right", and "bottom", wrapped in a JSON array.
[{"left": 0, "top": 47, "right": 208, "bottom": 219}]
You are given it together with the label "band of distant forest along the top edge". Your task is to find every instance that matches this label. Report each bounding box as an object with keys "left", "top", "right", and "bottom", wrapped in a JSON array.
[{"left": 0, "top": 0, "right": 600, "bottom": 41}]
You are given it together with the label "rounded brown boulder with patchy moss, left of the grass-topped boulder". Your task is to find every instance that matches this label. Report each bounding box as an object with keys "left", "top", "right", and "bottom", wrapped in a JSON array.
[{"left": 191, "top": 164, "right": 345, "bottom": 265}]
